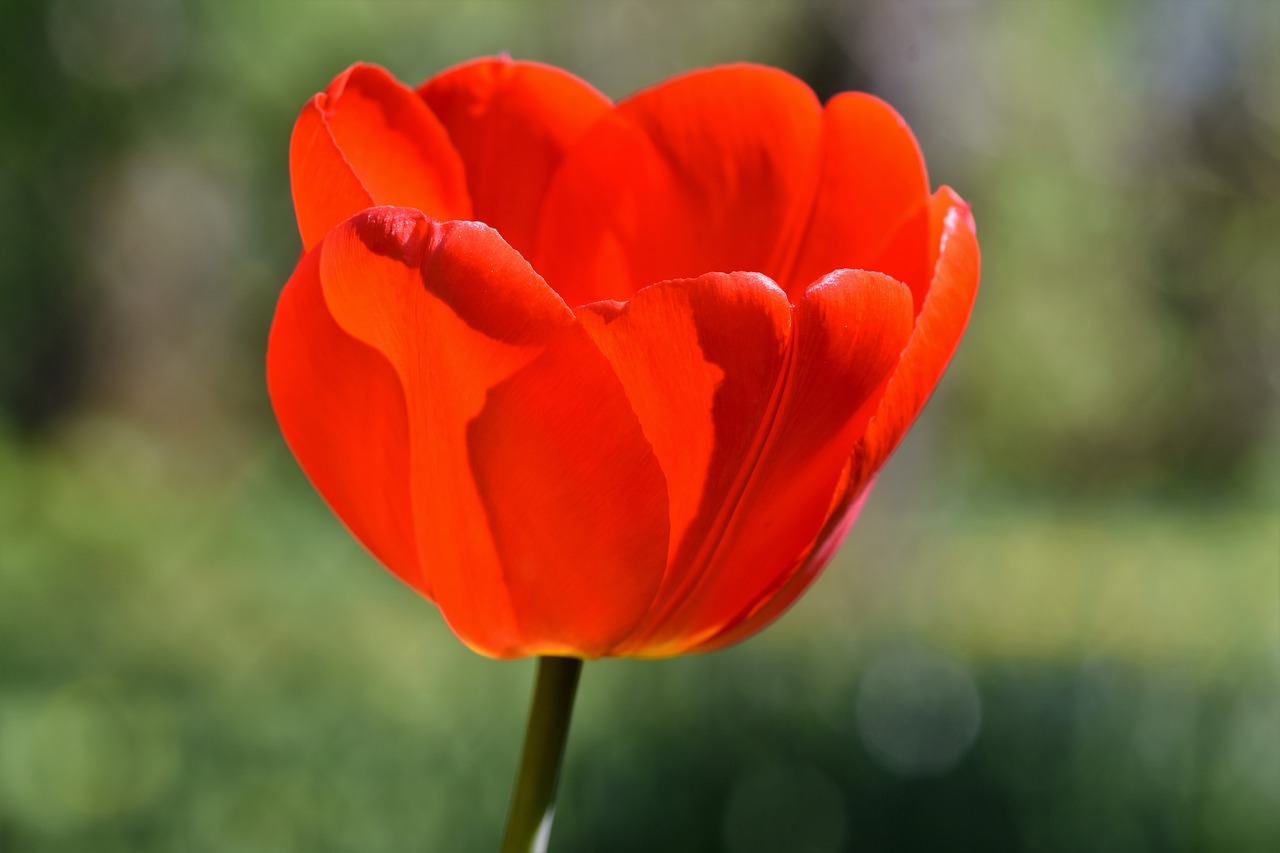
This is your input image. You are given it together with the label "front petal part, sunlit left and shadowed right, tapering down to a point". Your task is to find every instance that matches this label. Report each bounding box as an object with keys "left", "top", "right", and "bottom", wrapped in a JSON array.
[{"left": 579, "top": 273, "right": 791, "bottom": 573}]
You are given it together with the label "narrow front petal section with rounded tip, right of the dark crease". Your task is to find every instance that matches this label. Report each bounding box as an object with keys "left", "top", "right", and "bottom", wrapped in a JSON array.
[{"left": 623, "top": 270, "right": 911, "bottom": 656}]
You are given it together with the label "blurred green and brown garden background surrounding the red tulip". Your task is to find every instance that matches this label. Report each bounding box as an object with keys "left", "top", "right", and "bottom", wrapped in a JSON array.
[{"left": 0, "top": 0, "right": 1280, "bottom": 853}]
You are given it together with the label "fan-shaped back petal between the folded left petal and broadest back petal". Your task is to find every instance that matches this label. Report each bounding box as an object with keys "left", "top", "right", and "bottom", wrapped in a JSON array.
[{"left": 417, "top": 58, "right": 612, "bottom": 257}]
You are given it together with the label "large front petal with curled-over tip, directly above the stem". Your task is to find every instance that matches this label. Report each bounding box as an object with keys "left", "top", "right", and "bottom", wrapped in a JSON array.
[{"left": 320, "top": 207, "right": 667, "bottom": 657}]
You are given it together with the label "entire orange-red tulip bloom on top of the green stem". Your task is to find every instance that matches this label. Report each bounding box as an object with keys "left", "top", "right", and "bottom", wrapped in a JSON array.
[{"left": 268, "top": 59, "right": 978, "bottom": 657}]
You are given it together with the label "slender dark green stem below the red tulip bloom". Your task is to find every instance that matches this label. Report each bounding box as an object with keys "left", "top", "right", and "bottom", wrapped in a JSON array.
[{"left": 502, "top": 657, "right": 582, "bottom": 853}]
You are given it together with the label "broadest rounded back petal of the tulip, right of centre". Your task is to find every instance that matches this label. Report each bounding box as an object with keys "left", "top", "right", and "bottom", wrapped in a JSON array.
[{"left": 534, "top": 65, "right": 822, "bottom": 305}]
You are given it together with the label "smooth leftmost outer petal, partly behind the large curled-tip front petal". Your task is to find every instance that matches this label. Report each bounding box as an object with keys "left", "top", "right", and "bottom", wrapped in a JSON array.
[{"left": 266, "top": 251, "right": 431, "bottom": 597}]
